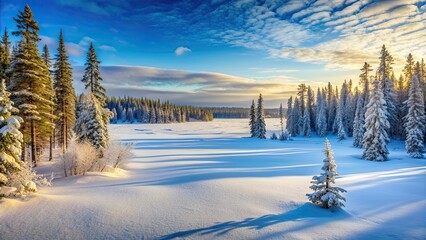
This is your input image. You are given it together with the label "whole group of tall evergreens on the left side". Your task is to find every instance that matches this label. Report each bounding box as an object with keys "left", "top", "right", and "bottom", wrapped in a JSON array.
[{"left": 0, "top": 5, "right": 112, "bottom": 195}]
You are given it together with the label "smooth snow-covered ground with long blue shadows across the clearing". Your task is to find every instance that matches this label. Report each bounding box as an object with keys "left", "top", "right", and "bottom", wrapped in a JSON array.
[{"left": 0, "top": 119, "right": 426, "bottom": 239}]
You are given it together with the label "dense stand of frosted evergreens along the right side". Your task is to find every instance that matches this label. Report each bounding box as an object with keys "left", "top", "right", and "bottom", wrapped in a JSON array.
[{"left": 286, "top": 45, "right": 426, "bottom": 161}]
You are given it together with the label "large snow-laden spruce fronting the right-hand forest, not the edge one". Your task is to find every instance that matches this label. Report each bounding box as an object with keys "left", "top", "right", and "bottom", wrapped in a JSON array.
[{"left": 362, "top": 80, "right": 389, "bottom": 161}]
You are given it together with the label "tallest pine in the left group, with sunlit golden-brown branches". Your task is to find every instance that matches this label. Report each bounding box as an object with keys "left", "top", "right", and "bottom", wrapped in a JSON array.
[{"left": 6, "top": 5, "right": 54, "bottom": 165}]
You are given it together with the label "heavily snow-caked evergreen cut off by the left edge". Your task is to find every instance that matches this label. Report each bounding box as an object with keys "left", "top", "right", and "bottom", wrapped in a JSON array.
[{"left": 0, "top": 80, "right": 23, "bottom": 193}]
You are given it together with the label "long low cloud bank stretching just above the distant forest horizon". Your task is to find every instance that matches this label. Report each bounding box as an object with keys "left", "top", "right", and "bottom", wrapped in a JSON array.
[{"left": 74, "top": 66, "right": 306, "bottom": 107}]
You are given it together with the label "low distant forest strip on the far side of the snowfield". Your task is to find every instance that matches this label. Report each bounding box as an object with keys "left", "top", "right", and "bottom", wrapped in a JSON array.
[{"left": 106, "top": 97, "right": 213, "bottom": 123}]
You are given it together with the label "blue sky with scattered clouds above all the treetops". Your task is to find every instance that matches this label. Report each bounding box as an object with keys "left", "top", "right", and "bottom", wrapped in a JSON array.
[{"left": 0, "top": 0, "right": 426, "bottom": 107}]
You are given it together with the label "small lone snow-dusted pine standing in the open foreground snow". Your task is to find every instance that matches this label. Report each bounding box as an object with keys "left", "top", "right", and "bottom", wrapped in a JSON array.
[{"left": 306, "top": 139, "right": 346, "bottom": 208}]
